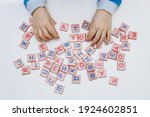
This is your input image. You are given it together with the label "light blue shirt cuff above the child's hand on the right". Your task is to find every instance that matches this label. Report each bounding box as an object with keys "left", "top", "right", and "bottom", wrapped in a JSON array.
[{"left": 97, "top": 0, "right": 118, "bottom": 15}]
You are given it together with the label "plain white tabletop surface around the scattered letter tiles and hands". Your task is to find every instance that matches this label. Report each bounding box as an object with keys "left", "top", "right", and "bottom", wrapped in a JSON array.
[{"left": 0, "top": 0, "right": 150, "bottom": 99}]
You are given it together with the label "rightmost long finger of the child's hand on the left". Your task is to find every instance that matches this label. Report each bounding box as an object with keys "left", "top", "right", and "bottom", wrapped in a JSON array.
[{"left": 46, "top": 23, "right": 59, "bottom": 38}]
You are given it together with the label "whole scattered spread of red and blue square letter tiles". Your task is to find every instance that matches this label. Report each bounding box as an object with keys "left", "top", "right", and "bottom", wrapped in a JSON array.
[{"left": 14, "top": 20, "right": 137, "bottom": 94}]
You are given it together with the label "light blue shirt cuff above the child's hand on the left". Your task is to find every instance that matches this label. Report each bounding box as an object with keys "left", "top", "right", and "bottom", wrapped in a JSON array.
[{"left": 27, "top": 0, "right": 46, "bottom": 14}]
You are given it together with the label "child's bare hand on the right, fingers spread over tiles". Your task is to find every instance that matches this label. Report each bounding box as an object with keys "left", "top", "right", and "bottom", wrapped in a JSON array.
[{"left": 87, "top": 10, "right": 112, "bottom": 48}]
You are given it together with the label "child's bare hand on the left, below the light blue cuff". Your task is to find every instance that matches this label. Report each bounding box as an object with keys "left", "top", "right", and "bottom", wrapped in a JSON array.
[{"left": 32, "top": 7, "right": 59, "bottom": 41}]
